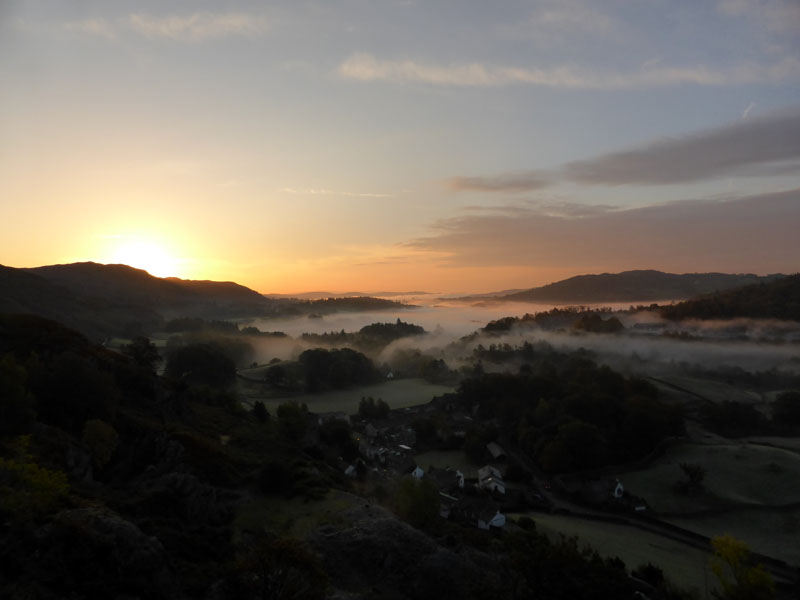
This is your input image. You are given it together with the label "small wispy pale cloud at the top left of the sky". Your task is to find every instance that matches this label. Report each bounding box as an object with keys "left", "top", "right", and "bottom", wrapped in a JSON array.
[{"left": 127, "top": 12, "right": 269, "bottom": 42}]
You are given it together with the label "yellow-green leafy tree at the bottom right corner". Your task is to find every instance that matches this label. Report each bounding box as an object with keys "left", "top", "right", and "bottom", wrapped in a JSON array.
[{"left": 711, "top": 535, "right": 775, "bottom": 600}]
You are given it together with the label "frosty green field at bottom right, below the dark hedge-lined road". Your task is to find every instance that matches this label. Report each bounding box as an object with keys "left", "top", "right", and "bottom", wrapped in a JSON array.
[{"left": 509, "top": 512, "right": 717, "bottom": 598}]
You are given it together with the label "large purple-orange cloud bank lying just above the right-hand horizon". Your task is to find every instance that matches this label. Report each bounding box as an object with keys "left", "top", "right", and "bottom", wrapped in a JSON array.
[{"left": 405, "top": 189, "right": 800, "bottom": 273}]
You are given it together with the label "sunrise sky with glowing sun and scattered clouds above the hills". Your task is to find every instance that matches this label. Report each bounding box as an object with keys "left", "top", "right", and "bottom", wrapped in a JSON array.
[{"left": 0, "top": 0, "right": 800, "bottom": 293}]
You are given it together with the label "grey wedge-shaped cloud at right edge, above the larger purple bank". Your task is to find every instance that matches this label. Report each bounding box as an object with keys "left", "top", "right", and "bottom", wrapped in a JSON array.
[{"left": 563, "top": 107, "right": 800, "bottom": 185}]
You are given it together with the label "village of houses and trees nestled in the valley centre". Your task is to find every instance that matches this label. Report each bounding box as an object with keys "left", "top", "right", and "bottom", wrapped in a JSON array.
[{"left": 307, "top": 396, "right": 647, "bottom": 533}]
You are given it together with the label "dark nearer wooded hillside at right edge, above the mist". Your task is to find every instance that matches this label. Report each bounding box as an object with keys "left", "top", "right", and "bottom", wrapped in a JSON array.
[{"left": 661, "top": 274, "right": 800, "bottom": 321}]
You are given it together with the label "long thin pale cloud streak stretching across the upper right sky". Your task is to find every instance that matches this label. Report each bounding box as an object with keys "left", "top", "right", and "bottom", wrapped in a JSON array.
[{"left": 336, "top": 53, "right": 800, "bottom": 90}]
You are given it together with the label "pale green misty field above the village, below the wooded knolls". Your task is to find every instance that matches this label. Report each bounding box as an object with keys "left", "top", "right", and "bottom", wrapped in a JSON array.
[{"left": 240, "top": 379, "right": 453, "bottom": 415}]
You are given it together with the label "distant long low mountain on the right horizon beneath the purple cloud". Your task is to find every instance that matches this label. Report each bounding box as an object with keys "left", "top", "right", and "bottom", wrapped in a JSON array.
[{"left": 475, "top": 270, "right": 785, "bottom": 304}]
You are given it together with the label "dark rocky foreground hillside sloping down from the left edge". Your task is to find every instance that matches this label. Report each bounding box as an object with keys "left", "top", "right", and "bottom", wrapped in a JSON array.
[{"left": 0, "top": 315, "right": 664, "bottom": 600}]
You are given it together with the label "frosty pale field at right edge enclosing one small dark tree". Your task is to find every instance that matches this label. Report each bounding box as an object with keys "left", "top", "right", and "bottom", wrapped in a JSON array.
[{"left": 618, "top": 443, "right": 800, "bottom": 513}]
